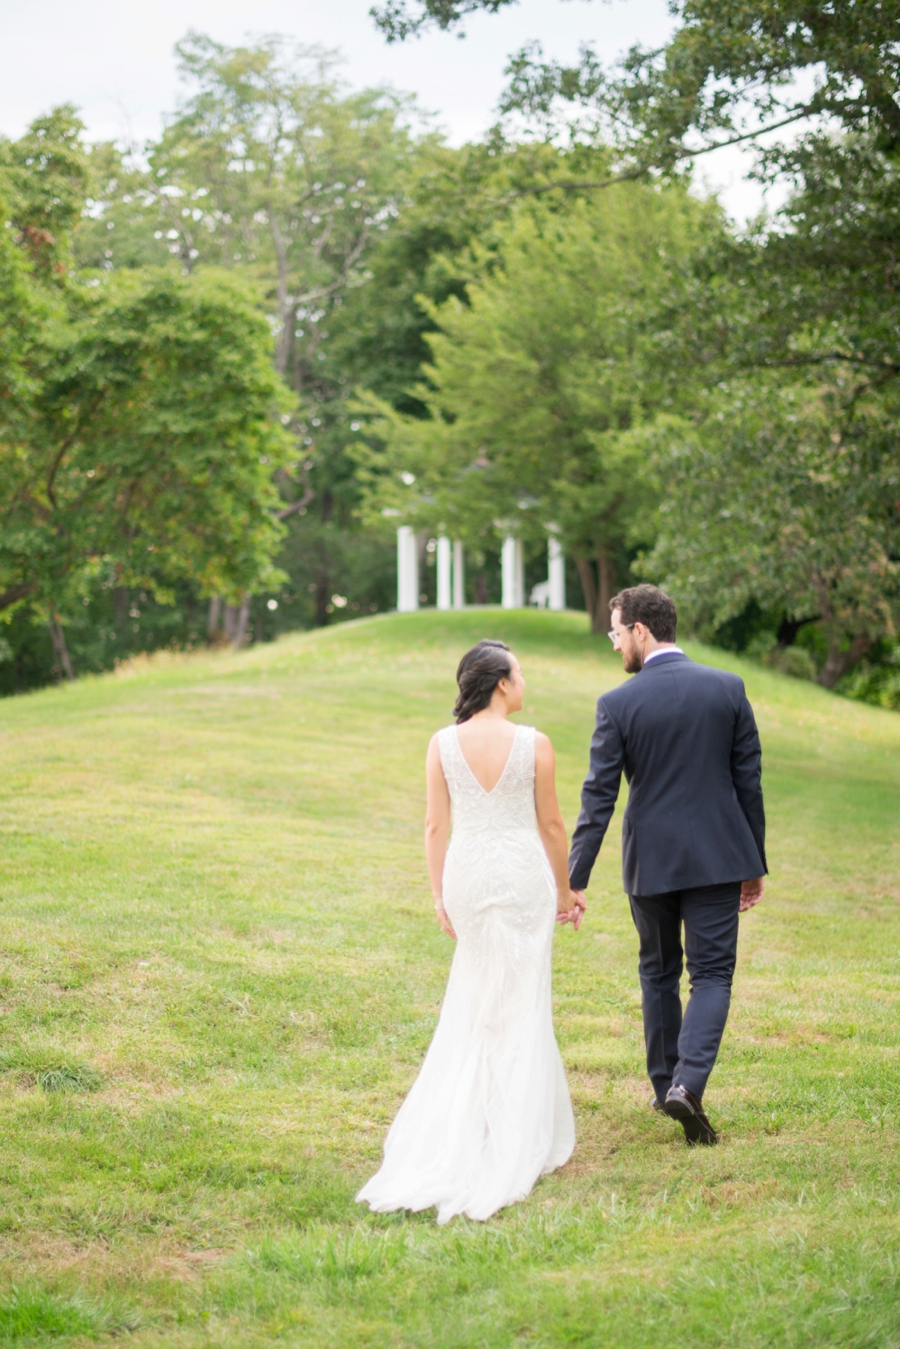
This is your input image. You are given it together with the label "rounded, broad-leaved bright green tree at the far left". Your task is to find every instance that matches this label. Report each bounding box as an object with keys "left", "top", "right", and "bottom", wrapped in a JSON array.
[{"left": 0, "top": 257, "right": 293, "bottom": 673}]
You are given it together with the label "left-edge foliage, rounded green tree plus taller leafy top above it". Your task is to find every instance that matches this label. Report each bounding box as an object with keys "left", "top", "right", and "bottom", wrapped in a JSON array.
[{"left": 0, "top": 108, "right": 306, "bottom": 687}]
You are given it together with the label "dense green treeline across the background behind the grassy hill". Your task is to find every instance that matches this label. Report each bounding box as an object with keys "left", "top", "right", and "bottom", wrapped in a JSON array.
[{"left": 0, "top": 10, "right": 900, "bottom": 704}]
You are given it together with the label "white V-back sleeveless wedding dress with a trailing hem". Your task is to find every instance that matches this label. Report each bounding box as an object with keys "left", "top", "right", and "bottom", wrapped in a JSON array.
[{"left": 356, "top": 726, "right": 575, "bottom": 1224}]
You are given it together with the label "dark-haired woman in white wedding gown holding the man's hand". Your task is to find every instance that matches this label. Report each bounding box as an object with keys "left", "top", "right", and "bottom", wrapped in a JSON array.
[{"left": 356, "top": 641, "right": 584, "bottom": 1224}]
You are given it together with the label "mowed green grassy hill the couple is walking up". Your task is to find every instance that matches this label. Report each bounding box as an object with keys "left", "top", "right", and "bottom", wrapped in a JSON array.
[{"left": 0, "top": 610, "right": 900, "bottom": 1349}]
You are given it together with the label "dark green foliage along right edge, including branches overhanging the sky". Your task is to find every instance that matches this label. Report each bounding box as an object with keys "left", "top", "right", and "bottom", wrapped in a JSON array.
[{"left": 474, "top": 0, "right": 900, "bottom": 684}]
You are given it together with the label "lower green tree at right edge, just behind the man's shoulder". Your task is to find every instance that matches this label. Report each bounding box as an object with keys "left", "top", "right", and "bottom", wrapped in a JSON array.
[{"left": 644, "top": 370, "right": 900, "bottom": 688}]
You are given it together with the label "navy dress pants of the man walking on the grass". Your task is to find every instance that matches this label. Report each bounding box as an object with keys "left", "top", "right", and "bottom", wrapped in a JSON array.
[{"left": 629, "top": 881, "right": 741, "bottom": 1101}]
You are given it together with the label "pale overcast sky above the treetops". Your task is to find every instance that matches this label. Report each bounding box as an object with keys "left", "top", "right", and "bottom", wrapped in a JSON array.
[{"left": 0, "top": 0, "right": 777, "bottom": 219}]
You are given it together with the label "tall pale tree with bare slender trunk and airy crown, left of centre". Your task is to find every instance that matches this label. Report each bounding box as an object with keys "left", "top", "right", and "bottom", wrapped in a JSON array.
[{"left": 82, "top": 34, "right": 431, "bottom": 621}]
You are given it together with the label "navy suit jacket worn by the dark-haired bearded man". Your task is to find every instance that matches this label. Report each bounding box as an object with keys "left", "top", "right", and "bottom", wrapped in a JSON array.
[{"left": 569, "top": 652, "right": 768, "bottom": 894}]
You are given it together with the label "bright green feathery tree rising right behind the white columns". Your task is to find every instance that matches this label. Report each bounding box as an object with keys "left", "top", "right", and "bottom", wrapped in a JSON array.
[{"left": 363, "top": 185, "right": 721, "bottom": 631}]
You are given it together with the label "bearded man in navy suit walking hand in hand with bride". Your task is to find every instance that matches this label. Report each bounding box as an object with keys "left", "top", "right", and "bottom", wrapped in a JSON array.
[{"left": 569, "top": 585, "right": 766, "bottom": 1145}]
